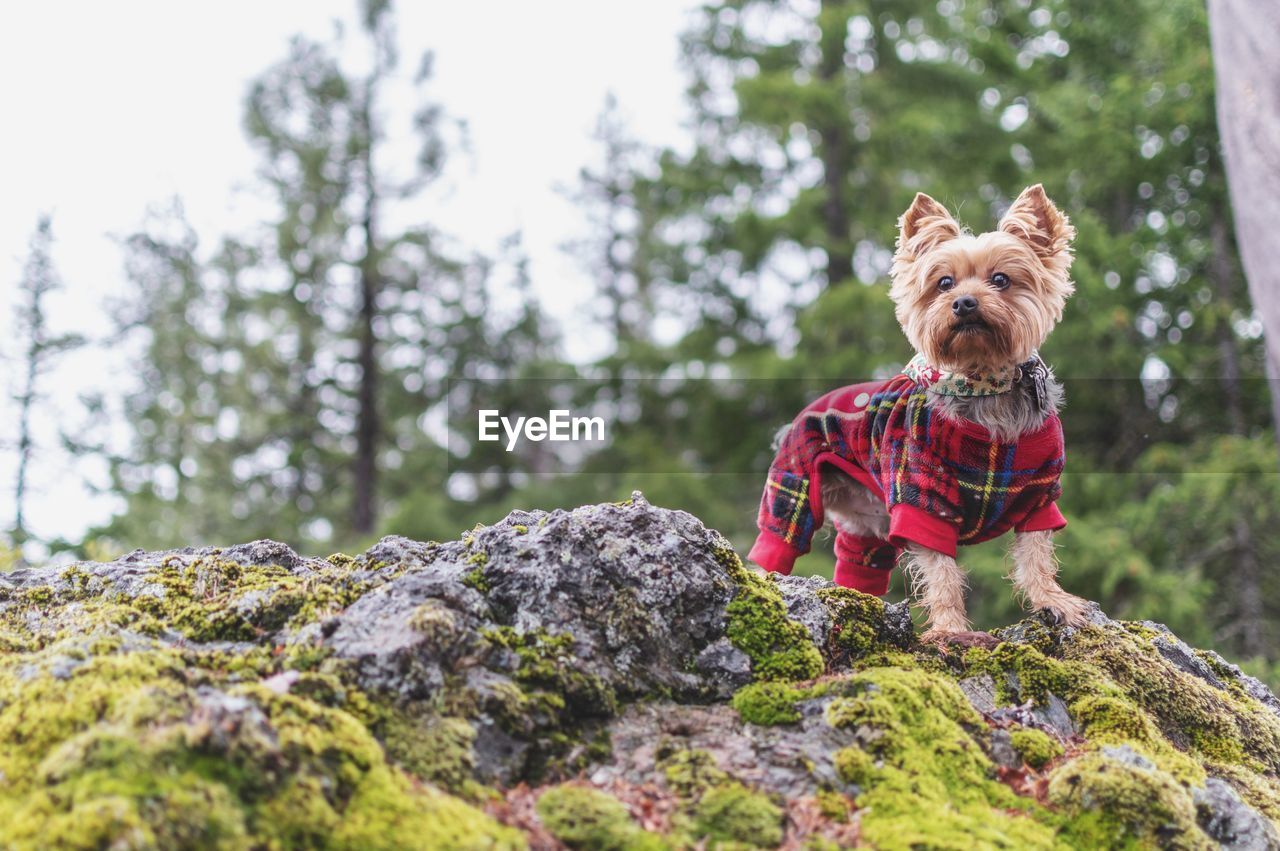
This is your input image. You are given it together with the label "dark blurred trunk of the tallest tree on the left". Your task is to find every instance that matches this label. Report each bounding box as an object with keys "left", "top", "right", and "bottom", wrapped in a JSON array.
[{"left": 352, "top": 91, "right": 380, "bottom": 535}]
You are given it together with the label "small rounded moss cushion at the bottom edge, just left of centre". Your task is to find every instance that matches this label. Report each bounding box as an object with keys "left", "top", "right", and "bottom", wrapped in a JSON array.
[{"left": 536, "top": 786, "right": 672, "bottom": 851}]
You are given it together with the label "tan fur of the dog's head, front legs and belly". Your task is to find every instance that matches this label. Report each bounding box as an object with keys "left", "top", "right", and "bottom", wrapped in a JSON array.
[{"left": 885, "top": 184, "right": 1085, "bottom": 641}]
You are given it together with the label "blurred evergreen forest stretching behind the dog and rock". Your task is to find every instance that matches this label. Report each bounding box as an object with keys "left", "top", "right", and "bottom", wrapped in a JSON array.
[{"left": 5, "top": 0, "right": 1280, "bottom": 676}]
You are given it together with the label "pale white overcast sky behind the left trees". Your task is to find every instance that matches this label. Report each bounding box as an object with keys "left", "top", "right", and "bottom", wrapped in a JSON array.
[{"left": 0, "top": 0, "right": 699, "bottom": 547}]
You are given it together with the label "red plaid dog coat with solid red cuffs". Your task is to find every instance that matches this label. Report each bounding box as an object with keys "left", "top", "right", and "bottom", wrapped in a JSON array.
[{"left": 748, "top": 374, "right": 1066, "bottom": 595}]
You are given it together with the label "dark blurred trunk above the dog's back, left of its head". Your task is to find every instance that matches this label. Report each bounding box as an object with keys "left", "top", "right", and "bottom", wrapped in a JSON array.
[{"left": 818, "top": 0, "right": 854, "bottom": 287}]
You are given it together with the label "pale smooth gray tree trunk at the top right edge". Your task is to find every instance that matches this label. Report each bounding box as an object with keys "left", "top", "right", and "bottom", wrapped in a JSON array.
[{"left": 1208, "top": 0, "right": 1280, "bottom": 450}]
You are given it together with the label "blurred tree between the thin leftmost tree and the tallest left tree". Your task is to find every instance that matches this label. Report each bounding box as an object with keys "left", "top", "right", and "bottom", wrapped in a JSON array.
[{"left": 89, "top": 201, "right": 254, "bottom": 545}]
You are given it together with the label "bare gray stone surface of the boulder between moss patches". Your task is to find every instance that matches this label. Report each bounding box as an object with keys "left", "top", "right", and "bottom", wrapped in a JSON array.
[{"left": 0, "top": 495, "right": 1280, "bottom": 850}]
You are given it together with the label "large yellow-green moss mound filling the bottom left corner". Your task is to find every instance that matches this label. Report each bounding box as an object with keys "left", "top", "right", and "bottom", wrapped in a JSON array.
[{"left": 0, "top": 641, "right": 524, "bottom": 848}]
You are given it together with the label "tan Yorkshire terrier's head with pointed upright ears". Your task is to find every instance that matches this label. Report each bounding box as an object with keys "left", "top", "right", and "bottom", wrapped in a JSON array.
[{"left": 890, "top": 184, "right": 1075, "bottom": 372}]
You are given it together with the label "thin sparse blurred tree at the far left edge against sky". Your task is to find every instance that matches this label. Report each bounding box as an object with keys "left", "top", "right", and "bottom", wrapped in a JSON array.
[{"left": 10, "top": 215, "right": 84, "bottom": 552}]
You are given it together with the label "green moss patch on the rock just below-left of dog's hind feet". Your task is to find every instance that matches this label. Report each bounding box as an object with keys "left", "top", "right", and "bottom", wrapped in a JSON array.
[{"left": 713, "top": 548, "right": 824, "bottom": 680}]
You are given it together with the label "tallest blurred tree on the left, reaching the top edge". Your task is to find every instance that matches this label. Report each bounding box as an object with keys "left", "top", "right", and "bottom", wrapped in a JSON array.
[{"left": 238, "top": 0, "right": 427, "bottom": 535}]
